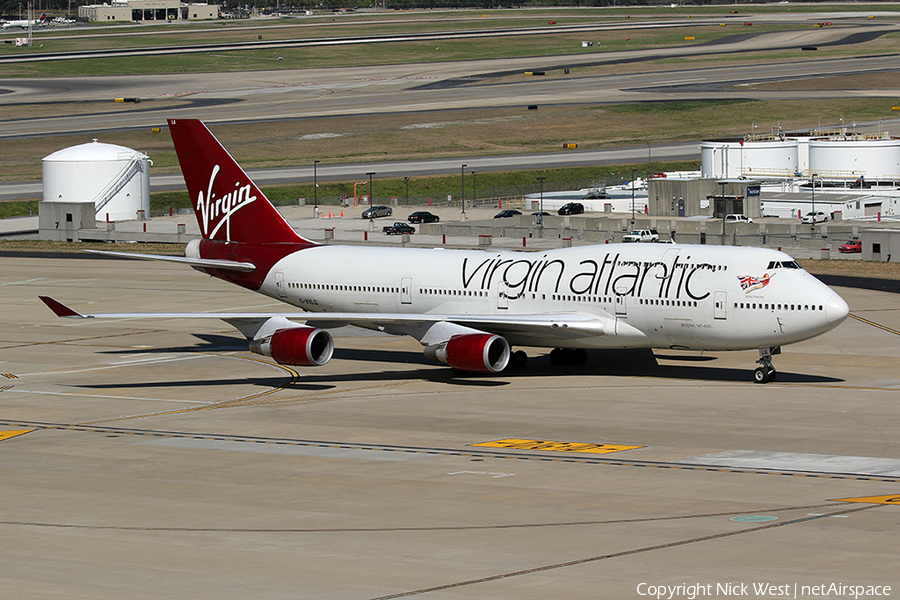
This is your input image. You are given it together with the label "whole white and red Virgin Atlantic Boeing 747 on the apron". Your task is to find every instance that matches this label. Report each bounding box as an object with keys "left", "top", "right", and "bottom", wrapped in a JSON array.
[{"left": 42, "top": 119, "right": 849, "bottom": 383}]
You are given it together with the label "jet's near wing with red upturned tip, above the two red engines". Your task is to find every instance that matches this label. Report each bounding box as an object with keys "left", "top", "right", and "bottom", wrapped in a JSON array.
[{"left": 40, "top": 296, "right": 632, "bottom": 343}]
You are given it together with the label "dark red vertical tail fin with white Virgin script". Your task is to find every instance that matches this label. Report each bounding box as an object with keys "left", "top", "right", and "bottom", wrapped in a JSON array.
[{"left": 169, "top": 119, "right": 313, "bottom": 245}]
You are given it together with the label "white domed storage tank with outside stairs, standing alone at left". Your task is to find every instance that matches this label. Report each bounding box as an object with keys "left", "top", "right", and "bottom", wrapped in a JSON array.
[{"left": 42, "top": 140, "right": 150, "bottom": 221}]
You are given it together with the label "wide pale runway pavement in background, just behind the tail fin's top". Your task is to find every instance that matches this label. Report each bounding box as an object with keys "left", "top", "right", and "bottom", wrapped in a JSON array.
[{"left": 0, "top": 24, "right": 897, "bottom": 139}]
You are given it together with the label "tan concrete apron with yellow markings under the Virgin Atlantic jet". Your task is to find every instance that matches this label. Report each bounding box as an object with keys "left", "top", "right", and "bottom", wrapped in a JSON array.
[{"left": 0, "top": 252, "right": 900, "bottom": 600}]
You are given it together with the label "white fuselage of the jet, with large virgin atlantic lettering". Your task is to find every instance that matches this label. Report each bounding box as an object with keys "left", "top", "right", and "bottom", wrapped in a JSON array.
[{"left": 260, "top": 244, "right": 848, "bottom": 350}]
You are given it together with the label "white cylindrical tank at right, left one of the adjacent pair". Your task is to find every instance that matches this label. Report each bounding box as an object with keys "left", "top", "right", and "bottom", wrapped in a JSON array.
[{"left": 700, "top": 139, "right": 799, "bottom": 179}]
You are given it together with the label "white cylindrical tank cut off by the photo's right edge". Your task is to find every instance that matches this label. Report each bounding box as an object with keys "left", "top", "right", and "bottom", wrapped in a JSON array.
[{"left": 809, "top": 134, "right": 900, "bottom": 181}]
